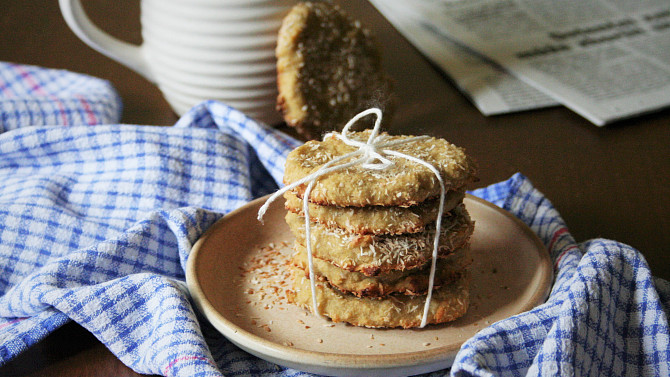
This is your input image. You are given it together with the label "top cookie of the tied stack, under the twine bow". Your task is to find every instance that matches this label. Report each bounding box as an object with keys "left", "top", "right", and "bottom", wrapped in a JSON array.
[{"left": 284, "top": 130, "right": 477, "bottom": 207}]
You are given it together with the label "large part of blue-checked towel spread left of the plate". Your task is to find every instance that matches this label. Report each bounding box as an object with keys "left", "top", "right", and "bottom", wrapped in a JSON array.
[{"left": 0, "top": 98, "right": 298, "bottom": 376}]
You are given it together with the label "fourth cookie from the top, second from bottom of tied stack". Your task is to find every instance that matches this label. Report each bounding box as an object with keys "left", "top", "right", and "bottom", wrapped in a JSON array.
[{"left": 291, "top": 244, "right": 466, "bottom": 297}]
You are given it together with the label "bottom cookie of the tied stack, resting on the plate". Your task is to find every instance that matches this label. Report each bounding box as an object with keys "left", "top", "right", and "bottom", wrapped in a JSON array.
[{"left": 287, "top": 266, "right": 469, "bottom": 328}]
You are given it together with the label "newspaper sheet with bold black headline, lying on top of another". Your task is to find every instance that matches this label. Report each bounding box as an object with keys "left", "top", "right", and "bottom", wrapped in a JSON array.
[{"left": 372, "top": 0, "right": 670, "bottom": 126}]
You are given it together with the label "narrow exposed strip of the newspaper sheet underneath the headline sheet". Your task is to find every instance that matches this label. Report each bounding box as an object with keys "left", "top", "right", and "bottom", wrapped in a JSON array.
[{"left": 370, "top": 0, "right": 558, "bottom": 116}]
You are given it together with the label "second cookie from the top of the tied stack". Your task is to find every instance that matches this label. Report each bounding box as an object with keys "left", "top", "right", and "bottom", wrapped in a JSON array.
[{"left": 284, "top": 189, "right": 465, "bottom": 234}]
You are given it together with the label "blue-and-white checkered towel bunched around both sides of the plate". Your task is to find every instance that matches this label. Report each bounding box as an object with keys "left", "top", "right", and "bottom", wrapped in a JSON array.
[{"left": 0, "top": 63, "right": 670, "bottom": 376}]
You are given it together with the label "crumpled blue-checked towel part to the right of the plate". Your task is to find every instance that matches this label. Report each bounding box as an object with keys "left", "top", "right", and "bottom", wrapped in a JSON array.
[{"left": 451, "top": 174, "right": 670, "bottom": 376}]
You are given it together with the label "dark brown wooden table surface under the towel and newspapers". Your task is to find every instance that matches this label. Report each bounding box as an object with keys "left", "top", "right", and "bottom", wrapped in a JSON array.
[{"left": 0, "top": 0, "right": 670, "bottom": 376}]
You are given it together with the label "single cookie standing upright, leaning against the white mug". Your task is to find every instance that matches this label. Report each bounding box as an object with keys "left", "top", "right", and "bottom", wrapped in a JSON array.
[{"left": 276, "top": 1, "right": 392, "bottom": 139}]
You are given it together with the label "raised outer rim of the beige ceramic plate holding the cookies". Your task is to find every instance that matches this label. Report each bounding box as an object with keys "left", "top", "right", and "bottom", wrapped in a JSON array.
[{"left": 186, "top": 193, "right": 554, "bottom": 372}]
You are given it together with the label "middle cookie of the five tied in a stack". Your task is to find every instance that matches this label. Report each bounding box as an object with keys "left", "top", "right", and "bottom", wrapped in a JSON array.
[{"left": 286, "top": 205, "right": 474, "bottom": 276}]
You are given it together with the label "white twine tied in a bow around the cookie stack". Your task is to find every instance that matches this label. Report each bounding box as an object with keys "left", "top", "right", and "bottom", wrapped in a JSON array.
[{"left": 258, "top": 108, "right": 446, "bottom": 328}]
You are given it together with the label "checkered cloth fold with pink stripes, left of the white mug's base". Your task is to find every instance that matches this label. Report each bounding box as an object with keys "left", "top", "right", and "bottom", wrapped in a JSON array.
[{"left": 0, "top": 62, "right": 121, "bottom": 132}]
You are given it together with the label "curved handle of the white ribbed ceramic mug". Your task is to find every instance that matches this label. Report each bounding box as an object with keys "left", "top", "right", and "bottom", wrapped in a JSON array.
[{"left": 58, "top": 0, "right": 155, "bottom": 82}]
